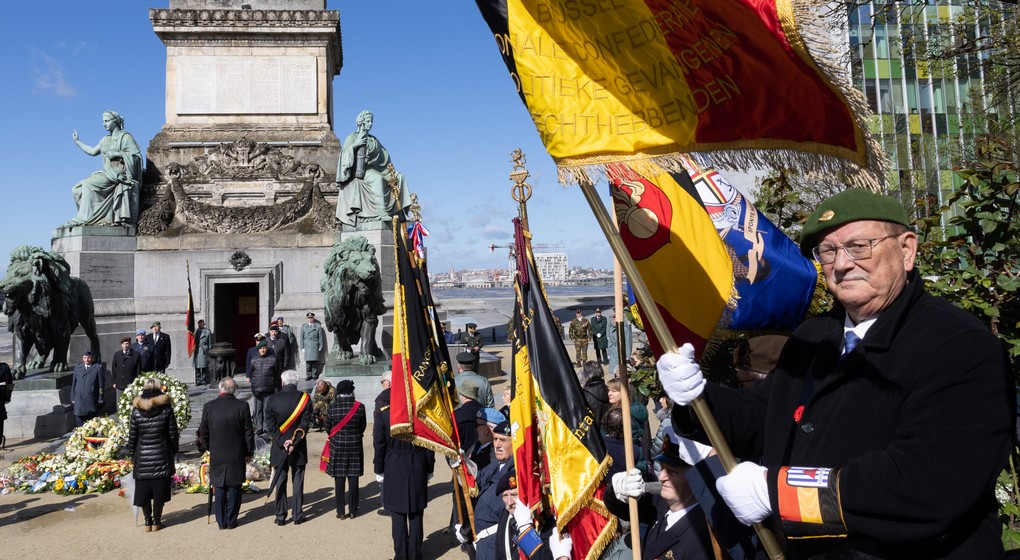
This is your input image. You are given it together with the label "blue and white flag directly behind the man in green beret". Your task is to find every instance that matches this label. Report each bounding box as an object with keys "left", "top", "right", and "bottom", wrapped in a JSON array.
[{"left": 679, "top": 157, "right": 818, "bottom": 330}]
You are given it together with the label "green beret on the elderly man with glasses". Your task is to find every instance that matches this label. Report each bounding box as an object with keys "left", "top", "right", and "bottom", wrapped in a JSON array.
[{"left": 801, "top": 189, "right": 910, "bottom": 258}]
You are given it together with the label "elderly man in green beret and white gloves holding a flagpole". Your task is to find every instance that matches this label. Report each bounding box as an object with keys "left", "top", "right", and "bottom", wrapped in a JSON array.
[{"left": 658, "top": 189, "right": 1015, "bottom": 559}]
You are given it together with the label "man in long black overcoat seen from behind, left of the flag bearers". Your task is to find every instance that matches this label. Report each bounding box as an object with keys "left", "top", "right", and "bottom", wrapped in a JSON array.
[{"left": 372, "top": 375, "right": 436, "bottom": 560}]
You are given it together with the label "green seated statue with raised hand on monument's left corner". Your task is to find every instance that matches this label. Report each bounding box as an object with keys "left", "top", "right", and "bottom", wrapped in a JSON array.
[{"left": 67, "top": 111, "right": 142, "bottom": 225}]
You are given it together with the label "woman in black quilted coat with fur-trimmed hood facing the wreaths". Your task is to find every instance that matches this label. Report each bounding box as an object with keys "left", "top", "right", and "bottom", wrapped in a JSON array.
[{"left": 128, "top": 378, "right": 180, "bottom": 532}]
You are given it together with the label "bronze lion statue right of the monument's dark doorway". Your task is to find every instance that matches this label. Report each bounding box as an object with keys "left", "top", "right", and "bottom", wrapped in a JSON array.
[{"left": 319, "top": 236, "right": 386, "bottom": 365}]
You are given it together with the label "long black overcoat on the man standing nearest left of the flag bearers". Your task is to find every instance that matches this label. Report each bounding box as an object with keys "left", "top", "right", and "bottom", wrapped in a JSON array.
[{"left": 372, "top": 389, "right": 436, "bottom": 513}]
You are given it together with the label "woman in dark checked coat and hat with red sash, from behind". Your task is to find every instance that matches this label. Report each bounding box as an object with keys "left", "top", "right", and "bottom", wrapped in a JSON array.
[{"left": 325, "top": 379, "right": 367, "bottom": 519}]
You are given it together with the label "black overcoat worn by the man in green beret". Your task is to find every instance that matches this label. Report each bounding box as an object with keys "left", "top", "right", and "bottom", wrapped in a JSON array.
[{"left": 673, "top": 274, "right": 1014, "bottom": 559}]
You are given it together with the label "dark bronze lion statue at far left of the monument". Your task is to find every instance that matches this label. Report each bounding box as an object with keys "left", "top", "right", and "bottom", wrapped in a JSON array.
[{"left": 0, "top": 245, "right": 102, "bottom": 379}]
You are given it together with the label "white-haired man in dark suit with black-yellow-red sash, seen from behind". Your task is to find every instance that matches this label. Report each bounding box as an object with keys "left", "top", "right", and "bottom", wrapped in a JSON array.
[{"left": 265, "top": 369, "right": 312, "bottom": 525}]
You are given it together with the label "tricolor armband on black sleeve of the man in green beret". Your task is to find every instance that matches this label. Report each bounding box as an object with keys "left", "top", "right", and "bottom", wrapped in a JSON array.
[{"left": 776, "top": 467, "right": 847, "bottom": 539}]
